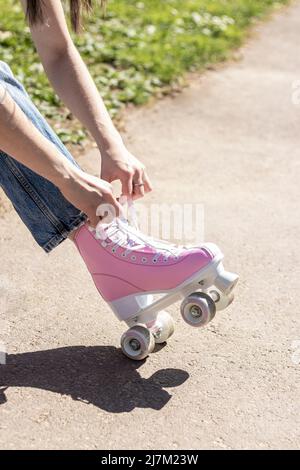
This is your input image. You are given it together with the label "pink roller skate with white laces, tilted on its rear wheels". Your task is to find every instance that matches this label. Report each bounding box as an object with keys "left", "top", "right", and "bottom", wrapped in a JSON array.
[{"left": 75, "top": 215, "right": 238, "bottom": 360}]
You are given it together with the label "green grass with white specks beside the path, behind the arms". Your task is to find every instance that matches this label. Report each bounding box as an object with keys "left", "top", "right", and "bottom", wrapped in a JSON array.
[{"left": 0, "top": 0, "right": 288, "bottom": 143}]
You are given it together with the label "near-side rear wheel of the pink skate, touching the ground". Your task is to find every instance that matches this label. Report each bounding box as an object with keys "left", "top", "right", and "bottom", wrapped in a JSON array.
[{"left": 121, "top": 325, "right": 155, "bottom": 361}]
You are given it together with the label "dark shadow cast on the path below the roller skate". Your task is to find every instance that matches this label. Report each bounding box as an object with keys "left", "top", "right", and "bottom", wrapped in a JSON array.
[{"left": 0, "top": 346, "right": 189, "bottom": 413}]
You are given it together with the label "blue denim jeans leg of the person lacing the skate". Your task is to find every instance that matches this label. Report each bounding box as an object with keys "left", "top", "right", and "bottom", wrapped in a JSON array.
[{"left": 0, "top": 61, "right": 86, "bottom": 253}]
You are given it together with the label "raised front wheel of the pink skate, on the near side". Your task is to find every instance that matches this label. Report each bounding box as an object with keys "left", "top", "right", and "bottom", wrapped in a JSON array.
[{"left": 180, "top": 292, "right": 216, "bottom": 328}]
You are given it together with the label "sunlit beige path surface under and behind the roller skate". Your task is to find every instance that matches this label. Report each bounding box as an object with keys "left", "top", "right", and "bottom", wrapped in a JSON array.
[{"left": 0, "top": 2, "right": 300, "bottom": 449}]
